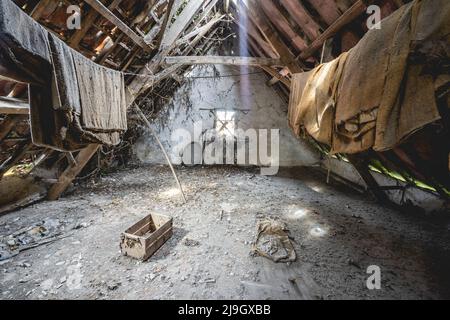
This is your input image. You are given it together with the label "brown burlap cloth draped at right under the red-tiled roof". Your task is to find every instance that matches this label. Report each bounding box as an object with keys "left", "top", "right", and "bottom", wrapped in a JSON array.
[{"left": 289, "top": 0, "right": 450, "bottom": 153}]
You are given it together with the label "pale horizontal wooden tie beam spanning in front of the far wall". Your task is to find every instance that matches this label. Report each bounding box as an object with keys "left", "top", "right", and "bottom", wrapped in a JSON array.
[{"left": 164, "top": 56, "right": 281, "bottom": 67}]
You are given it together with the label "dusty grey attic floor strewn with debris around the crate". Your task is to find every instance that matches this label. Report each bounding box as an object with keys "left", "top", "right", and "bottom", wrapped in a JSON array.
[{"left": 0, "top": 167, "right": 450, "bottom": 299}]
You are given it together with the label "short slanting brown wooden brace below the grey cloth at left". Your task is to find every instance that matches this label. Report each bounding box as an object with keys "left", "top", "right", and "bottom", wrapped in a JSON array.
[{"left": 47, "top": 144, "right": 100, "bottom": 200}]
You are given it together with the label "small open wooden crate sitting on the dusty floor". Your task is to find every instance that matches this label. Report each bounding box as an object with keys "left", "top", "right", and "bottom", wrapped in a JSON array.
[{"left": 120, "top": 214, "right": 173, "bottom": 261}]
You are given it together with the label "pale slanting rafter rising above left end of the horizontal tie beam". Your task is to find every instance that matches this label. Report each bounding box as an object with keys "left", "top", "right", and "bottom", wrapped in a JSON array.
[{"left": 161, "top": 0, "right": 205, "bottom": 47}]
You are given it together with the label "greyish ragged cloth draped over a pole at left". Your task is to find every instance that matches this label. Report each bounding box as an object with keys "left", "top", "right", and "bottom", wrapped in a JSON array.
[{"left": 0, "top": 0, "right": 127, "bottom": 151}]
